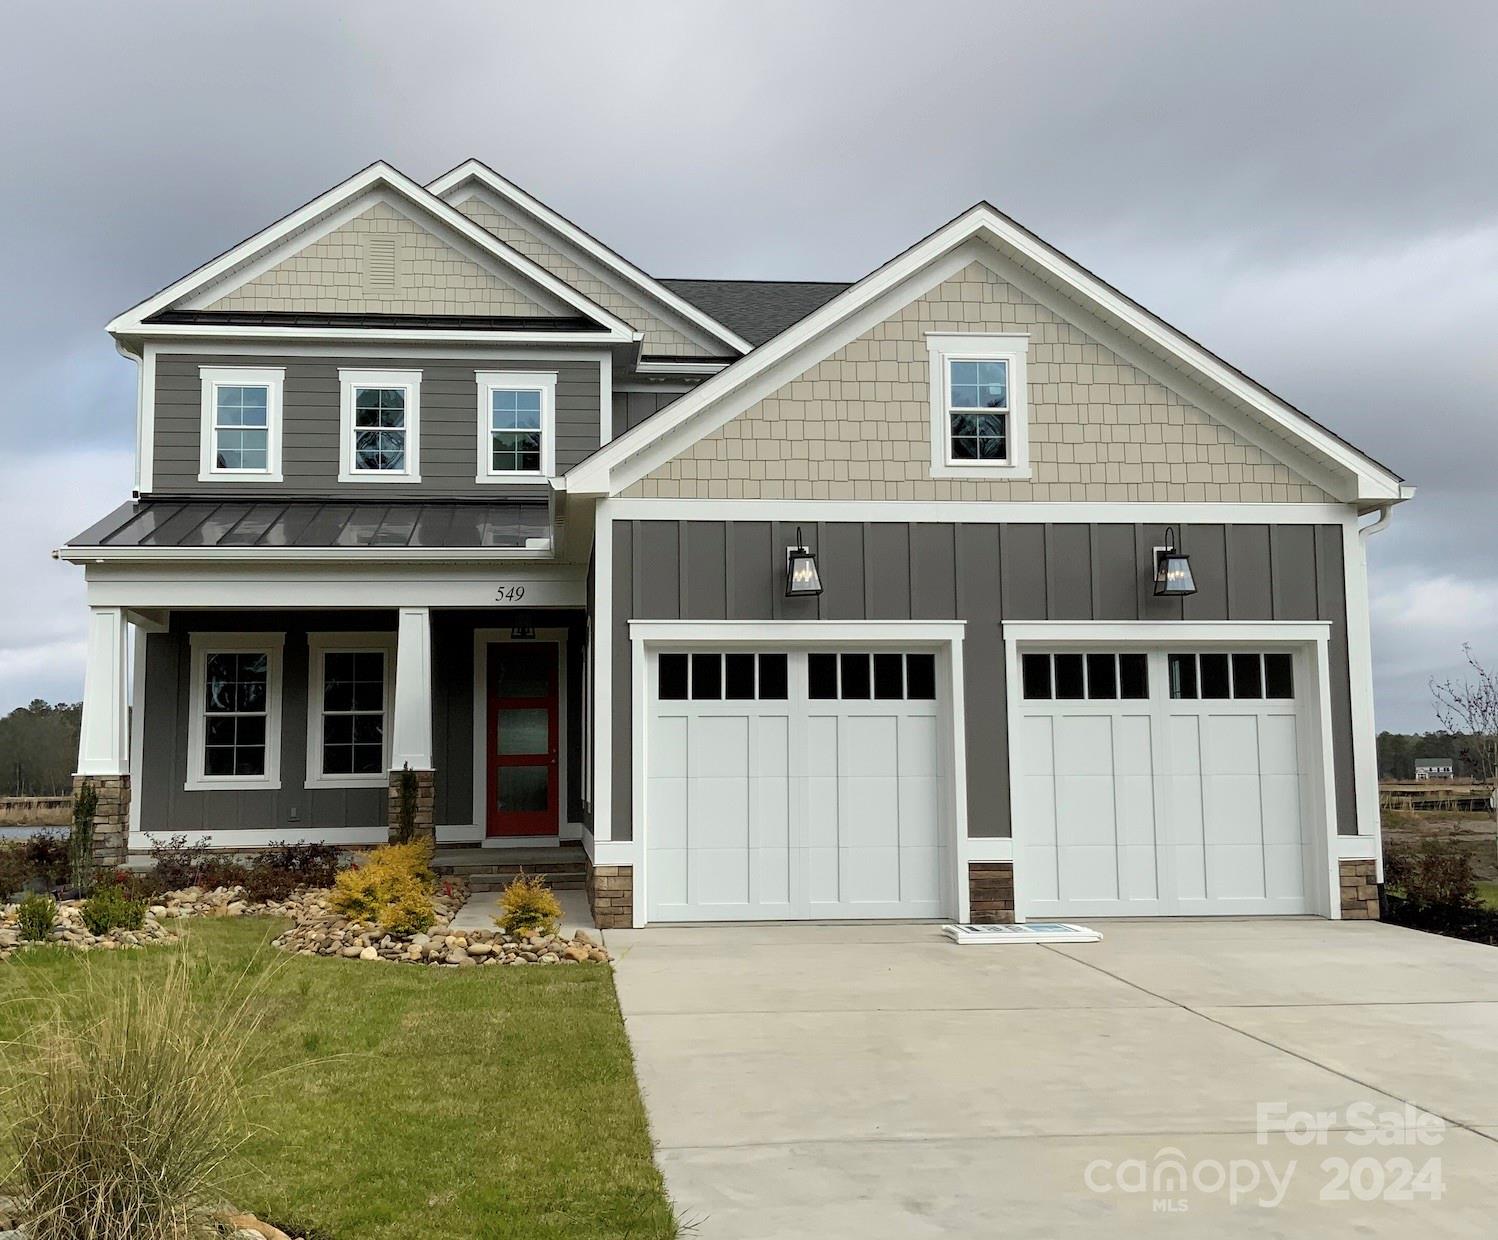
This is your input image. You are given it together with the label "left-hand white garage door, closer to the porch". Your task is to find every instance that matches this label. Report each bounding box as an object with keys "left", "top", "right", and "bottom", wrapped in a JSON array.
[{"left": 644, "top": 650, "right": 951, "bottom": 921}]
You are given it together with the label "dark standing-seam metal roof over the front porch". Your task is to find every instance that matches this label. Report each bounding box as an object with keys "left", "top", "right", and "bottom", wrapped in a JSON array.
[{"left": 67, "top": 497, "right": 551, "bottom": 550}]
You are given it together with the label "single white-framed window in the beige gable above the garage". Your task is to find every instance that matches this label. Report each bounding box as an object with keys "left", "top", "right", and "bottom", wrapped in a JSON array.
[{"left": 926, "top": 332, "right": 1031, "bottom": 479}]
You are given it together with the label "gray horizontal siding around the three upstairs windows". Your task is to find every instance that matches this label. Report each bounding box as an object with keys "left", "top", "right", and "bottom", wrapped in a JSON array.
[{"left": 153, "top": 353, "right": 601, "bottom": 497}]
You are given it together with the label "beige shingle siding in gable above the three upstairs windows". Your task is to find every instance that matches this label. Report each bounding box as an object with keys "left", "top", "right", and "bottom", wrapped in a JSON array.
[{"left": 208, "top": 202, "right": 563, "bottom": 317}]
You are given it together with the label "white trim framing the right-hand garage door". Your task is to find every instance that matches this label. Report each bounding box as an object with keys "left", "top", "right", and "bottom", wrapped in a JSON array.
[{"left": 1004, "top": 620, "right": 1342, "bottom": 921}]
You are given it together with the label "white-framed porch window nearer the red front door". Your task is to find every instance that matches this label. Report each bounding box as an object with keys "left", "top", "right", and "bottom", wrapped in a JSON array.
[{"left": 307, "top": 633, "right": 395, "bottom": 788}]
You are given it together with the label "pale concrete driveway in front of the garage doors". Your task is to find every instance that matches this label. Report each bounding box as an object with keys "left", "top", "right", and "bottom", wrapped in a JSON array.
[{"left": 607, "top": 918, "right": 1498, "bottom": 1240}]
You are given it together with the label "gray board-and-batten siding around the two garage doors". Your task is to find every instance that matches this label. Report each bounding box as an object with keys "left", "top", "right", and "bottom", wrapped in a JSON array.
[{"left": 611, "top": 521, "right": 1357, "bottom": 840}]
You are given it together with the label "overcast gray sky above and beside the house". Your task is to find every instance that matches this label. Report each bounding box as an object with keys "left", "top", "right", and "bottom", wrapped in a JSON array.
[{"left": 0, "top": 0, "right": 1498, "bottom": 729}]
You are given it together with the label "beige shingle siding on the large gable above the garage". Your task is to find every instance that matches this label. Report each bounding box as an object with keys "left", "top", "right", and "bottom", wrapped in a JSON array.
[{"left": 625, "top": 262, "right": 1329, "bottom": 503}]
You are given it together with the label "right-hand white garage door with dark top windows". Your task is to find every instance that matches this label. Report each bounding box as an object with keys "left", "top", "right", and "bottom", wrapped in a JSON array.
[{"left": 1014, "top": 650, "right": 1311, "bottom": 917}]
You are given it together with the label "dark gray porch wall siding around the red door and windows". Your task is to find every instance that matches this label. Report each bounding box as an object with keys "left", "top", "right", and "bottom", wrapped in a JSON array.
[{"left": 135, "top": 610, "right": 587, "bottom": 845}]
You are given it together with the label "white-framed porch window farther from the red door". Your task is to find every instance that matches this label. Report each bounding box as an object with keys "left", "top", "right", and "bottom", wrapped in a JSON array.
[{"left": 186, "top": 633, "right": 285, "bottom": 791}]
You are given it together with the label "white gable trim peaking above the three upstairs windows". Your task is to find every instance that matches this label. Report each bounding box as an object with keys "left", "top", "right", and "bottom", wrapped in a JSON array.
[{"left": 108, "top": 162, "right": 637, "bottom": 341}]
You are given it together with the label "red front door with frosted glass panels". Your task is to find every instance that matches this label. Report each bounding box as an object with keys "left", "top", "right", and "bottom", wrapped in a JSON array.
[{"left": 485, "top": 641, "right": 562, "bottom": 837}]
